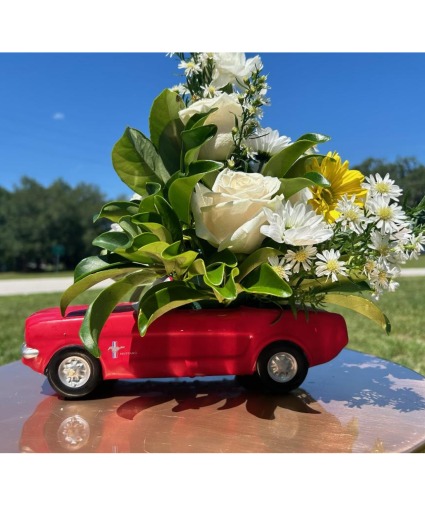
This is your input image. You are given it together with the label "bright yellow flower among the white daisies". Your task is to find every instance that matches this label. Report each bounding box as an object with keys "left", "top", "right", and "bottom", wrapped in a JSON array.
[{"left": 310, "top": 152, "right": 367, "bottom": 223}]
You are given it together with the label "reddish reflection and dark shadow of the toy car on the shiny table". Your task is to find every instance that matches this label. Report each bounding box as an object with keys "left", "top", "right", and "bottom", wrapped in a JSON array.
[{"left": 20, "top": 379, "right": 357, "bottom": 453}]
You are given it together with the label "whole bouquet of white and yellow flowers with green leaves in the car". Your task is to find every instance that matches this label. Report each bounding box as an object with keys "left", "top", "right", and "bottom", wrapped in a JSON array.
[{"left": 61, "top": 53, "right": 425, "bottom": 355}]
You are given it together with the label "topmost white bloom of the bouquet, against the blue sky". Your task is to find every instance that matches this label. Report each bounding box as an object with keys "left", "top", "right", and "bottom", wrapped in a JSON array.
[{"left": 211, "top": 52, "right": 262, "bottom": 89}]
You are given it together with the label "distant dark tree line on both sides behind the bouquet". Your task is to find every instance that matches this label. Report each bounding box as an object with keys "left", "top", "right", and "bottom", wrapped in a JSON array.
[{"left": 0, "top": 157, "right": 425, "bottom": 271}]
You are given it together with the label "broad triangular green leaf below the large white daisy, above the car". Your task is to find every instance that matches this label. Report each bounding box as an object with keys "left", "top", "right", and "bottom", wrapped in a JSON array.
[{"left": 240, "top": 263, "right": 292, "bottom": 299}]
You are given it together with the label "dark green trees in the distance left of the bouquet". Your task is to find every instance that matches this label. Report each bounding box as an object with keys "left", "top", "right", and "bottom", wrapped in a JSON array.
[{"left": 0, "top": 177, "right": 106, "bottom": 270}]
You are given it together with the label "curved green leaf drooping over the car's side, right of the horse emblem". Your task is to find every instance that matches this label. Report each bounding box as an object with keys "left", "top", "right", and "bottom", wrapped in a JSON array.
[{"left": 138, "top": 281, "right": 212, "bottom": 336}]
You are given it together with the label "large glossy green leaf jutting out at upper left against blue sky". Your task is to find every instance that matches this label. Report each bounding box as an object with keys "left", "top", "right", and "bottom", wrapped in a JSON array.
[{"left": 112, "top": 127, "right": 170, "bottom": 195}]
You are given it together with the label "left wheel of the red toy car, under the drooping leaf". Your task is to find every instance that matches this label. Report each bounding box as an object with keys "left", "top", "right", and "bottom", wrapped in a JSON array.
[{"left": 46, "top": 347, "right": 102, "bottom": 399}]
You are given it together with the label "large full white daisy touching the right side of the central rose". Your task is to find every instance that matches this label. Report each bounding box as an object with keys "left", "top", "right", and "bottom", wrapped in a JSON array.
[{"left": 260, "top": 202, "right": 333, "bottom": 247}]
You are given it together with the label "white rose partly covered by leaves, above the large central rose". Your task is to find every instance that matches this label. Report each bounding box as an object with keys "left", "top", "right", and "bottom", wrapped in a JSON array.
[{"left": 179, "top": 93, "right": 242, "bottom": 161}]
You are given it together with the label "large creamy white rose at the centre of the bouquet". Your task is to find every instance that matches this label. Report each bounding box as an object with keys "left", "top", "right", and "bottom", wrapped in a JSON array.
[{"left": 192, "top": 168, "right": 283, "bottom": 254}]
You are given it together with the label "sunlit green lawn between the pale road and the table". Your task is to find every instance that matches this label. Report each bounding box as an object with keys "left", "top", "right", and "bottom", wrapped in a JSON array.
[{"left": 0, "top": 277, "right": 425, "bottom": 375}]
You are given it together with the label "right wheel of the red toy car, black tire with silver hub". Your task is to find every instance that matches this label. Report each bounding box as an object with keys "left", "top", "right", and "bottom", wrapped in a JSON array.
[{"left": 257, "top": 342, "right": 308, "bottom": 393}]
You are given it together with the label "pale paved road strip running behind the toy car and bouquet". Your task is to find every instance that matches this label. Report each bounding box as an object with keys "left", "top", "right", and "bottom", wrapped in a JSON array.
[{"left": 0, "top": 268, "right": 425, "bottom": 296}]
